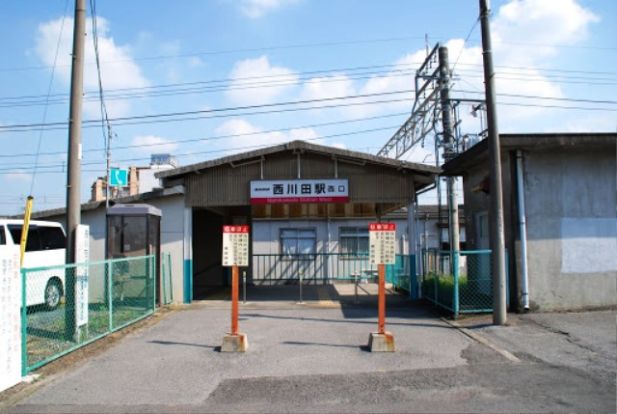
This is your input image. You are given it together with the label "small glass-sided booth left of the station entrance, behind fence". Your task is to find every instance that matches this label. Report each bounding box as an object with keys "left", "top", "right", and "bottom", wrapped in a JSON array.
[{"left": 106, "top": 204, "right": 161, "bottom": 305}]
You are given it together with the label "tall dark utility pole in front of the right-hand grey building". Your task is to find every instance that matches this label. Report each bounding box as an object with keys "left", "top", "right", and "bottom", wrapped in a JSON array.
[{"left": 480, "top": 0, "right": 507, "bottom": 325}]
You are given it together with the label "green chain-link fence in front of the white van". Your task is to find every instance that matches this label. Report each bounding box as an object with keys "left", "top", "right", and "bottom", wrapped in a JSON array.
[{"left": 21, "top": 256, "right": 156, "bottom": 375}]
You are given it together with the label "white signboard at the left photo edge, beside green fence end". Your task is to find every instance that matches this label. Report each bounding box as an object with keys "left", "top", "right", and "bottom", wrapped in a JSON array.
[{"left": 0, "top": 246, "right": 22, "bottom": 391}]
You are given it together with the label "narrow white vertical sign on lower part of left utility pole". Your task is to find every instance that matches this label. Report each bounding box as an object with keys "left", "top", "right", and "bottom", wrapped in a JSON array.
[{"left": 75, "top": 224, "right": 90, "bottom": 327}]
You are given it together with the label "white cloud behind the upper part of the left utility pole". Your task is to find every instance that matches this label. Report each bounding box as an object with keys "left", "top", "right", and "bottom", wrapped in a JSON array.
[{"left": 35, "top": 17, "right": 149, "bottom": 117}]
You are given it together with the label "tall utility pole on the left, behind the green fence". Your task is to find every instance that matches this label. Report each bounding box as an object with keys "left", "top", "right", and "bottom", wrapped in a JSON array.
[{"left": 65, "top": 0, "right": 86, "bottom": 339}]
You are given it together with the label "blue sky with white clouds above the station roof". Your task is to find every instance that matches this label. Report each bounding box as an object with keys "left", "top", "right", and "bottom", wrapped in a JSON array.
[{"left": 0, "top": 0, "right": 617, "bottom": 214}]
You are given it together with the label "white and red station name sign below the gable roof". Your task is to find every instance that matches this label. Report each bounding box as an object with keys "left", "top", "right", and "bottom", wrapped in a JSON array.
[{"left": 251, "top": 179, "right": 349, "bottom": 204}]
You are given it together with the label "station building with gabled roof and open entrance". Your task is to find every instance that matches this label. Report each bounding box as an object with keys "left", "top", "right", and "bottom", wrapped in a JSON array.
[{"left": 33, "top": 141, "right": 440, "bottom": 303}]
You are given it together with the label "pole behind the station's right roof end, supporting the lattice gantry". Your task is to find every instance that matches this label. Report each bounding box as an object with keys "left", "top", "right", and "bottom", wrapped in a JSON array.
[{"left": 439, "top": 46, "right": 460, "bottom": 258}]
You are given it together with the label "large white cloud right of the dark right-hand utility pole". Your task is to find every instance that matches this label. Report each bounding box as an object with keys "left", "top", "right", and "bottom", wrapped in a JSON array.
[{"left": 480, "top": 0, "right": 598, "bottom": 132}]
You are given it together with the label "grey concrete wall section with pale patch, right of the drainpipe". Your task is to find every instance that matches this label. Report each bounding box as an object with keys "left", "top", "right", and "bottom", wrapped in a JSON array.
[{"left": 524, "top": 149, "right": 617, "bottom": 310}]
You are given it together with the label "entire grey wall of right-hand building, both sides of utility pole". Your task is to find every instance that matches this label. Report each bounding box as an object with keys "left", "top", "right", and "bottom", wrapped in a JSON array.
[{"left": 464, "top": 147, "right": 617, "bottom": 311}]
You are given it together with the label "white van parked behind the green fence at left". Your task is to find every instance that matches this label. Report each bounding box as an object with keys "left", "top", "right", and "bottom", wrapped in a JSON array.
[{"left": 0, "top": 219, "right": 66, "bottom": 310}]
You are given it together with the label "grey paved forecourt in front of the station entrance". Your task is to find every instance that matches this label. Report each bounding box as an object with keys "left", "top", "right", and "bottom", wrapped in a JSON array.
[{"left": 0, "top": 286, "right": 617, "bottom": 413}]
